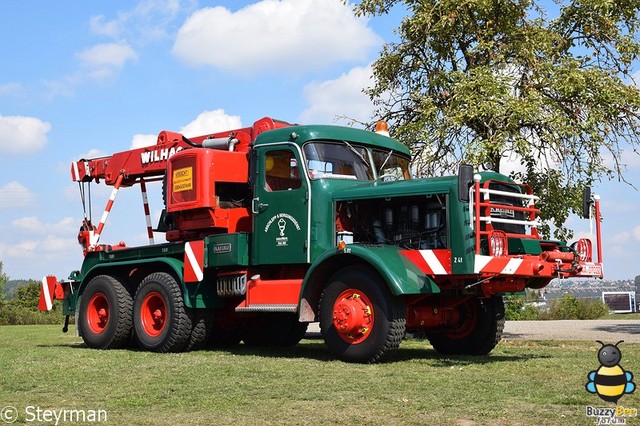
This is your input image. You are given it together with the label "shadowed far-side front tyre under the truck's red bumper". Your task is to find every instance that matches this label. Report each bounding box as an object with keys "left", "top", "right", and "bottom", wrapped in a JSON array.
[{"left": 428, "top": 296, "right": 504, "bottom": 355}]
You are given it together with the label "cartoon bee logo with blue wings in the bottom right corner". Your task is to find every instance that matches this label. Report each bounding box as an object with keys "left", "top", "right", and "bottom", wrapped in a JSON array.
[{"left": 585, "top": 340, "right": 636, "bottom": 404}]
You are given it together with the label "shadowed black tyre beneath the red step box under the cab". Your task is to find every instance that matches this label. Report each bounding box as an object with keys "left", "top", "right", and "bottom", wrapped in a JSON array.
[{"left": 242, "top": 313, "right": 308, "bottom": 346}]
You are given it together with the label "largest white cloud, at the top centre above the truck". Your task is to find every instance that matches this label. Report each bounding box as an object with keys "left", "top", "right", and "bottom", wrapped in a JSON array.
[{"left": 173, "top": 0, "right": 381, "bottom": 74}]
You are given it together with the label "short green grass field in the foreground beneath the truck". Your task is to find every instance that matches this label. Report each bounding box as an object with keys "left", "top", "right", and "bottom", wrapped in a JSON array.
[{"left": 0, "top": 325, "right": 640, "bottom": 426}]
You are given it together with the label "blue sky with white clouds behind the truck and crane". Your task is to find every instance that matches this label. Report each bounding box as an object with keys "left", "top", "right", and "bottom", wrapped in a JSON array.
[{"left": 0, "top": 0, "right": 640, "bottom": 279}]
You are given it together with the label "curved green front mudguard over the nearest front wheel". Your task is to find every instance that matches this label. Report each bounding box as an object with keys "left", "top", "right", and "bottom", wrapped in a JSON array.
[{"left": 299, "top": 244, "right": 440, "bottom": 321}]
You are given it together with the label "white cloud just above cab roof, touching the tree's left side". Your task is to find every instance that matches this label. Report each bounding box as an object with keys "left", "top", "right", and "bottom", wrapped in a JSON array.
[{"left": 297, "top": 66, "right": 374, "bottom": 124}]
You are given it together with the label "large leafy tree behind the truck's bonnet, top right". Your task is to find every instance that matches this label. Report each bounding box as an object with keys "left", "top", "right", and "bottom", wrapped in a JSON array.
[{"left": 355, "top": 0, "right": 640, "bottom": 239}]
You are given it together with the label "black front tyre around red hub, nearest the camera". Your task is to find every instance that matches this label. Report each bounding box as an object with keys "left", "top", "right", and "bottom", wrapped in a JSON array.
[{"left": 320, "top": 266, "right": 406, "bottom": 363}]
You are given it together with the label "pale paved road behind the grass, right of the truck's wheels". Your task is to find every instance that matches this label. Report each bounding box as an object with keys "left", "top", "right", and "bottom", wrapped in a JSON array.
[{"left": 307, "top": 320, "right": 640, "bottom": 343}]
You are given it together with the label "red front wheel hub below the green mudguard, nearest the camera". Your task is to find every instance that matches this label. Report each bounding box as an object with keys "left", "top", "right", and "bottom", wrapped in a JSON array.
[{"left": 333, "top": 288, "right": 374, "bottom": 344}]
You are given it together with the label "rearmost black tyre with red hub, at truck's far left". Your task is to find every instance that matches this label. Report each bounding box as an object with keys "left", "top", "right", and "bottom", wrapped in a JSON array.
[{"left": 78, "top": 275, "right": 133, "bottom": 349}]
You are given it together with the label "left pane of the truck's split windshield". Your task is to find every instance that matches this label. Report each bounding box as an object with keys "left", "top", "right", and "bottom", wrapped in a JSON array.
[{"left": 304, "top": 142, "right": 373, "bottom": 180}]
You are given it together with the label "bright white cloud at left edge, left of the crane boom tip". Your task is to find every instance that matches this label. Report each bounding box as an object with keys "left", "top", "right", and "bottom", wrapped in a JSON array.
[{"left": 0, "top": 115, "right": 51, "bottom": 155}]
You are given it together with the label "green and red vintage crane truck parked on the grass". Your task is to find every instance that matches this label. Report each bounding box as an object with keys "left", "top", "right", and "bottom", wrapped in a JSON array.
[{"left": 40, "top": 118, "right": 603, "bottom": 363}]
